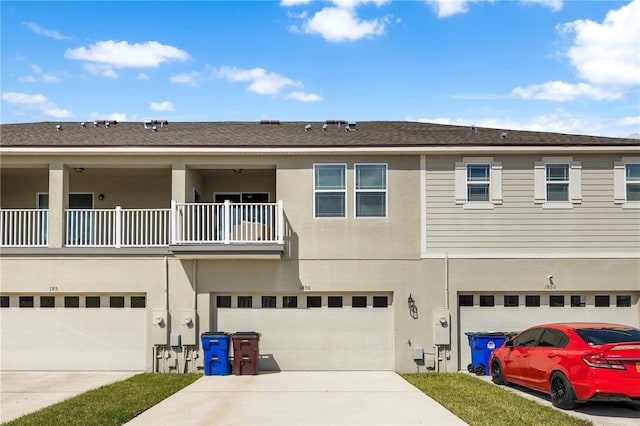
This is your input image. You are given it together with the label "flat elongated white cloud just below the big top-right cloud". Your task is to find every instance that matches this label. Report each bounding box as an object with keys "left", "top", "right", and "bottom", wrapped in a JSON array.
[{"left": 511, "top": 81, "right": 624, "bottom": 102}]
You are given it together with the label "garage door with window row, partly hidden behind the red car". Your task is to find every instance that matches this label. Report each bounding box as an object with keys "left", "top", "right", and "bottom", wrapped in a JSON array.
[{"left": 458, "top": 293, "right": 639, "bottom": 370}]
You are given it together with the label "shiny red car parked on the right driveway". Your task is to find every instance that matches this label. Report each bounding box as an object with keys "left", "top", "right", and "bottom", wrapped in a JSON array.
[{"left": 489, "top": 322, "right": 640, "bottom": 410}]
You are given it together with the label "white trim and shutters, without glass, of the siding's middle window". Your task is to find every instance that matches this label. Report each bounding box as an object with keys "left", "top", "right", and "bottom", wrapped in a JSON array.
[{"left": 533, "top": 157, "right": 582, "bottom": 209}]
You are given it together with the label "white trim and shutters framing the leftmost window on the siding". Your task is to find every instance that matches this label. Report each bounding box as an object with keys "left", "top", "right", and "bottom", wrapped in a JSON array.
[{"left": 455, "top": 157, "right": 503, "bottom": 210}]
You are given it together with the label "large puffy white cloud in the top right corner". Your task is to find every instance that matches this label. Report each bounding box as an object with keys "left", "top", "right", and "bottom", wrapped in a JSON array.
[{"left": 559, "top": 0, "right": 640, "bottom": 86}]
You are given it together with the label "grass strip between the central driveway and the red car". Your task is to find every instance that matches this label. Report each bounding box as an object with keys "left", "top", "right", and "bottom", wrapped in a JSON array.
[{"left": 402, "top": 373, "right": 593, "bottom": 426}]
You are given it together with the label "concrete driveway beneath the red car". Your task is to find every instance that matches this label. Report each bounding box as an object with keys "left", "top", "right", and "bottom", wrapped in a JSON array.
[{"left": 476, "top": 376, "right": 640, "bottom": 426}]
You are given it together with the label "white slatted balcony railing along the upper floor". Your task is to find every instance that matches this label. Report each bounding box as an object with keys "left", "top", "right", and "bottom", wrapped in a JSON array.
[{"left": 0, "top": 201, "right": 284, "bottom": 257}]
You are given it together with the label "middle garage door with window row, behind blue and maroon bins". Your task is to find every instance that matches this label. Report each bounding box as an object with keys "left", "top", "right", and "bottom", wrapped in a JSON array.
[{"left": 212, "top": 294, "right": 393, "bottom": 370}]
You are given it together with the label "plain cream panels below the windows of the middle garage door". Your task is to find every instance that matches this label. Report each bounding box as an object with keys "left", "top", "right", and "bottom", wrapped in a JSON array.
[{"left": 217, "top": 307, "right": 393, "bottom": 370}]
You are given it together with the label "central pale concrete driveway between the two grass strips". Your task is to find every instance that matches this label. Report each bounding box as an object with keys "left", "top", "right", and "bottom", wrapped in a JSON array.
[{"left": 127, "top": 371, "right": 465, "bottom": 426}]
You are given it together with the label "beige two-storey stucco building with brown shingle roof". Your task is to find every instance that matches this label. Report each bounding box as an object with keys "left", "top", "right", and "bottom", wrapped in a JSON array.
[{"left": 0, "top": 120, "right": 640, "bottom": 372}]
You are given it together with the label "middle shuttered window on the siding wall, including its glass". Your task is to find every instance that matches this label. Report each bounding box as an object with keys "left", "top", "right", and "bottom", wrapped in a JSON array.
[{"left": 534, "top": 157, "right": 582, "bottom": 208}]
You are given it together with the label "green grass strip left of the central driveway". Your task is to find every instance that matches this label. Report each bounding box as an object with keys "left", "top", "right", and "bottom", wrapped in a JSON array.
[{"left": 6, "top": 373, "right": 202, "bottom": 426}]
